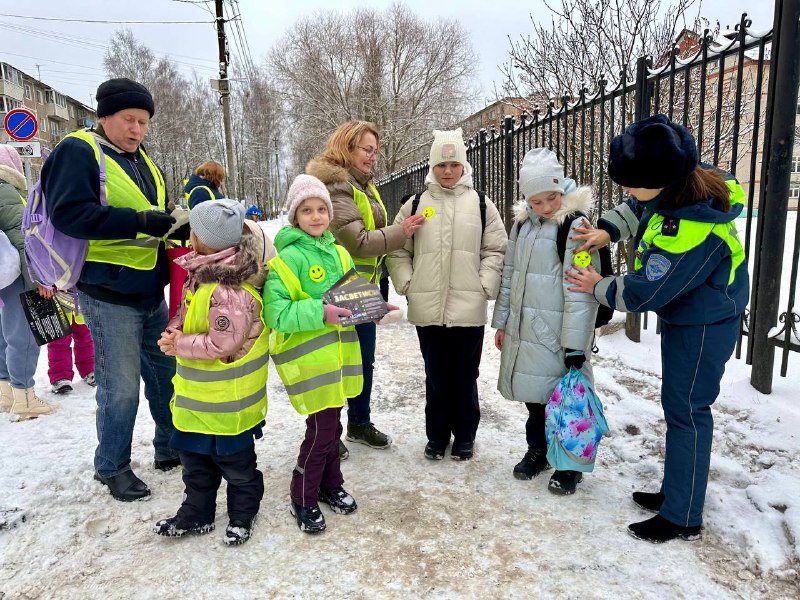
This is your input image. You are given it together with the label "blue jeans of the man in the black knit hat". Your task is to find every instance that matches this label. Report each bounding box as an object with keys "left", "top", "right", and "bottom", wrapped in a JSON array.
[{"left": 78, "top": 293, "right": 178, "bottom": 477}]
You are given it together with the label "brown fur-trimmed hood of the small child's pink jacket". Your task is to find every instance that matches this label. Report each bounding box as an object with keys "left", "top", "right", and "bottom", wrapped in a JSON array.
[{"left": 175, "top": 229, "right": 260, "bottom": 286}]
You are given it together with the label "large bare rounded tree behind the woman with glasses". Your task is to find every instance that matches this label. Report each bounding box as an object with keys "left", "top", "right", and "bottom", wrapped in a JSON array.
[{"left": 269, "top": 3, "right": 476, "bottom": 171}]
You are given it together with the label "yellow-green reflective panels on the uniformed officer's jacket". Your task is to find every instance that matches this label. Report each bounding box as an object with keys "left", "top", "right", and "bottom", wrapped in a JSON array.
[{"left": 634, "top": 179, "right": 746, "bottom": 284}]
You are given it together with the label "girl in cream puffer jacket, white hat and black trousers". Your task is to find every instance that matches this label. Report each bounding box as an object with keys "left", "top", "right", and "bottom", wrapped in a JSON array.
[{"left": 388, "top": 128, "right": 508, "bottom": 460}]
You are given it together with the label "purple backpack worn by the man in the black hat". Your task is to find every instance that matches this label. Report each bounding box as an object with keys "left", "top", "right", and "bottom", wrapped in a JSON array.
[{"left": 22, "top": 144, "right": 108, "bottom": 290}]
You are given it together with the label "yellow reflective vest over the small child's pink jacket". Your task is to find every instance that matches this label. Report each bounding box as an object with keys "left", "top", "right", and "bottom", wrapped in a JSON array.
[{"left": 170, "top": 283, "right": 269, "bottom": 435}]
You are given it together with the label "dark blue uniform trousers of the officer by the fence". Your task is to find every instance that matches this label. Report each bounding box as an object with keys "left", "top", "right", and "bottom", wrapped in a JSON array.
[{"left": 660, "top": 316, "right": 740, "bottom": 527}]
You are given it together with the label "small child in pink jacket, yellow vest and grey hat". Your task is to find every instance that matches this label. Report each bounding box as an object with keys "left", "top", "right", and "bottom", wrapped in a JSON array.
[{"left": 154, "top": 199, "right": 269, "bottom": 545}]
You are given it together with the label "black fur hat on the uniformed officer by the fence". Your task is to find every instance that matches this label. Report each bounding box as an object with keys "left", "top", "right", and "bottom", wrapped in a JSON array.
[{"left": 608, "top": 115, "right": 699, "bottom": 190}]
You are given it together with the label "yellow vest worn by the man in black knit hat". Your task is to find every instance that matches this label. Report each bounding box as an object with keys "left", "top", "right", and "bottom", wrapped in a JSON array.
[{"left": 65, "top": 131, "right": 166, "bottom": 271}]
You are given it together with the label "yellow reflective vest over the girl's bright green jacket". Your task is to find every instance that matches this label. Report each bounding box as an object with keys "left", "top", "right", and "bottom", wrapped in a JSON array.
[{"left": 269, "top": 245, "right": 364, "bottom": 415}]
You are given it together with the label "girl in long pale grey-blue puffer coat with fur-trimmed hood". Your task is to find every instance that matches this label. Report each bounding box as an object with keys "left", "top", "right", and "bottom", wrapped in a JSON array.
[{"left": 492, "top": 148, "right": 600, "bottom": 494}]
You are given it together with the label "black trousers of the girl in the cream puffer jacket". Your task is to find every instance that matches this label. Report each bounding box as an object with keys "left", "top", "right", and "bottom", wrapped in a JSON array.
[{"left": 417, "top": 325, "right": 483, "bottom": 445}]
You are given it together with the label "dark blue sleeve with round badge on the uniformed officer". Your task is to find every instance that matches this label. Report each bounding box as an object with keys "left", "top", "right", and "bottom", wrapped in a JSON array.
[{"left": 594, "top": 236, "right": 730, "bottom": 312}]
